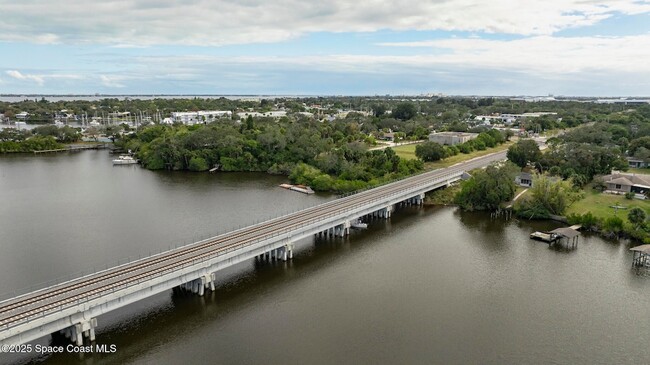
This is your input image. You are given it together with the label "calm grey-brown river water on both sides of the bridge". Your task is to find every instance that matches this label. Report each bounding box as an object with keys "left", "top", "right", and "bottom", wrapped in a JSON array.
[{"left": 0, "top": 151, "right": 650, "bottom": 364}]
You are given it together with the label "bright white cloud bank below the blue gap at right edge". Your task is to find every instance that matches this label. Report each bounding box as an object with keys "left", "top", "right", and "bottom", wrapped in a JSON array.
[{"left": 372, "top": 34, "right": 650, "bottom": 74}]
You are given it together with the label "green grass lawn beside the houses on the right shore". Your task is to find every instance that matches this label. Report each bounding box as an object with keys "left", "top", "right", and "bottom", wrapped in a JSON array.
[{"left": 565, "top": 185, "right": 650, "bottom": 220}]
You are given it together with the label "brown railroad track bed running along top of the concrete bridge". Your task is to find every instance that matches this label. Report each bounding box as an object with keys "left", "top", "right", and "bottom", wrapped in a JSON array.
[{"left": 0, "top": 152, "right": 505, "bottom": 328}]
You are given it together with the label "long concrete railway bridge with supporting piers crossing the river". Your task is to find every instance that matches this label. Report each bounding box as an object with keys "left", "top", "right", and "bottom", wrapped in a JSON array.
[{"left": 0, "top": 152, "right": 505, "bottom": 345}]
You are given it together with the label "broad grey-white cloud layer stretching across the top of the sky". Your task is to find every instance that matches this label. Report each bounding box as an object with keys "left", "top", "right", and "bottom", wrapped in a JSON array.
[{"left": 0, "top": 0, "right": 650, "bottom": 46}]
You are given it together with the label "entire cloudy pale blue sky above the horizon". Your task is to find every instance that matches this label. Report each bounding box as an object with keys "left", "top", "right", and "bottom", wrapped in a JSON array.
[{"left": 0, "top": 0, "right": 650, "bottom": 96}]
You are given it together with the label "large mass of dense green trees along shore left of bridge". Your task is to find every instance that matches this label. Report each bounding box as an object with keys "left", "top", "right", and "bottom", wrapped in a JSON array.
[{"left": 118, "top": 118, "right": 423, "bottom": 191}]
